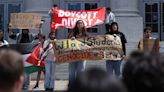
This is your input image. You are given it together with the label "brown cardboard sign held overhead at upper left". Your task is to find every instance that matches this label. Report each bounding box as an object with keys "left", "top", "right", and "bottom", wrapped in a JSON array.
[{"left": 10, "top": 13, "right": 41, "bottom": 29}]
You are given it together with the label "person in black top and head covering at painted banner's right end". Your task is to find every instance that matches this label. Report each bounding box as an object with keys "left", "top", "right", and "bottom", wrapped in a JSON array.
[{"left": 106, "top": 22, "right": 127, "bottom": 78}]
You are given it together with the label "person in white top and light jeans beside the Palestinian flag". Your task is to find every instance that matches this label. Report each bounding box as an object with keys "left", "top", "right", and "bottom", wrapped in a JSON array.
[{"left": 41, "top": 32, "right": 56, "bottom": 91}]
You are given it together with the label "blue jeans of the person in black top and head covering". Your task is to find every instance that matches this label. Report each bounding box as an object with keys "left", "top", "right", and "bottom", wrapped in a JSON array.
[{"left": 106, "top": 60, "right": 121, "bottom": 78}]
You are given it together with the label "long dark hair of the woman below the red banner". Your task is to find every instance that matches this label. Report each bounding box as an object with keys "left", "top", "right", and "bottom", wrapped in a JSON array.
[{"left": 73, "top": 20, "right": 87, "bottom": 37}]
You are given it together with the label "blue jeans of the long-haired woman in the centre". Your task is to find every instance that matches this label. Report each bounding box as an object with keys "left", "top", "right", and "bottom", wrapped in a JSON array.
[{"left": 69, "top": 61, "right": 86, "bottom": 86}]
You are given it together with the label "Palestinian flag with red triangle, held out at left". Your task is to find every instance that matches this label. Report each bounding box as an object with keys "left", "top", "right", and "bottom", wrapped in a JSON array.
[{"left": 9, "top": 43, "right": 44, "bottom": 73}]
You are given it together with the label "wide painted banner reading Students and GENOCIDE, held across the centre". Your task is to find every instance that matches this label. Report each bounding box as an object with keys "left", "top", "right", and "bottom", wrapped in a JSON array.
[{"left": 54, "top": 35, "right": 123, "bottom": 63}]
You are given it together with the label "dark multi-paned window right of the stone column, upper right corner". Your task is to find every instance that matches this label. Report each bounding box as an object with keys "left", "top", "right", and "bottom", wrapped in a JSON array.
[{"left": 139, "top": 0, "right": 164, "bottom": 41}]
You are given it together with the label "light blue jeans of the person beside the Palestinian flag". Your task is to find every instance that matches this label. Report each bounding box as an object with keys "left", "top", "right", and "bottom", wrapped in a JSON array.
[{"left": 44, "top": 61, "right": 56, "bottom": 89}]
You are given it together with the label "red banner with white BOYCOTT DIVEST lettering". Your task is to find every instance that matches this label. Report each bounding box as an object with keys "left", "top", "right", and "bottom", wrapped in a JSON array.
[{"left": 51, "top": 7, "right": 105, "bottom": 30}]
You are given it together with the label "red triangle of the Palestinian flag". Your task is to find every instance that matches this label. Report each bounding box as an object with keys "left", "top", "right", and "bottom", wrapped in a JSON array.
[{"left": 26, "top": 43, "right": 44, "bottom": 67}]
